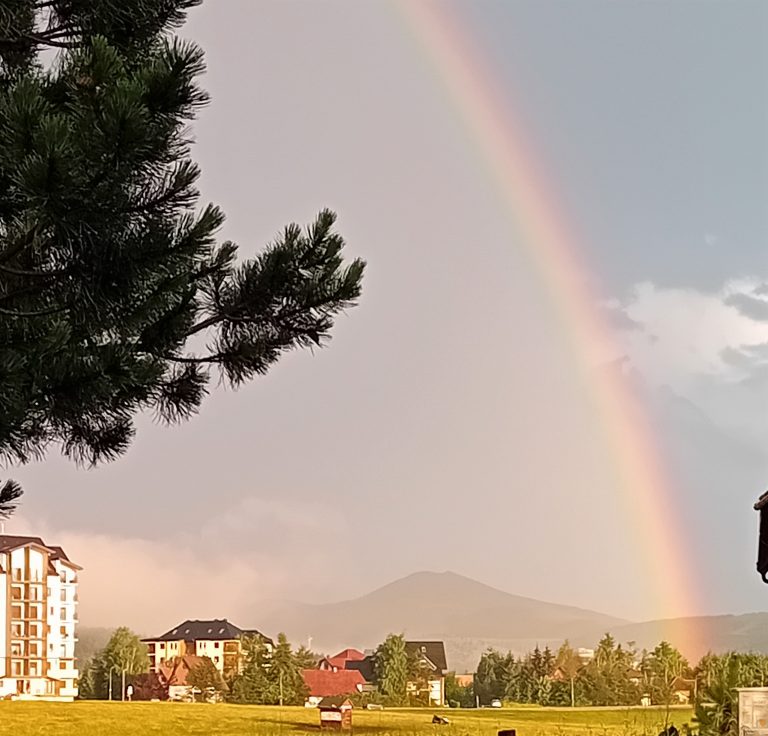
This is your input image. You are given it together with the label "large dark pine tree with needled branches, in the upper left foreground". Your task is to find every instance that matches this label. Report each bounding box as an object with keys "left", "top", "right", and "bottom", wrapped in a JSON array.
[{"left": 0, "top": 0, "right": 364, "bottom": 514}]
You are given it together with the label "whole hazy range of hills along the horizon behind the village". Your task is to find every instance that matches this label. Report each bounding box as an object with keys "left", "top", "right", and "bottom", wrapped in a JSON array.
[{"left": 78, "top": 572, "right": 768, "bottom": 672}]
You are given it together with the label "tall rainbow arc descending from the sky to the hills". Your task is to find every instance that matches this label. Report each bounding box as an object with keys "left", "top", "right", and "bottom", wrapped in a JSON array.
[{"left": 393, "top": 0, "right": 704, "bottom": 653}]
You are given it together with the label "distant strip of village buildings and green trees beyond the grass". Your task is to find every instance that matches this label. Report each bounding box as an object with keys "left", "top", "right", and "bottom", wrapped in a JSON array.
[{"left": 0, "top": 535, "right": 717, "bottom": 708}]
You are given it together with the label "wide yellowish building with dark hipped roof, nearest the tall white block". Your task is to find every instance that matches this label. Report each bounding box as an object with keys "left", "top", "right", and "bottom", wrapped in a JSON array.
[{"left": 142, "top": 619, "right": 273, "bottom": 676}]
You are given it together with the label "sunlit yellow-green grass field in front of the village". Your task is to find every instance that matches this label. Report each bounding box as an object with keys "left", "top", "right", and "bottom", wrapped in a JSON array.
[{"left": 0, "top": 701, "right": 691, "bottom": 736}]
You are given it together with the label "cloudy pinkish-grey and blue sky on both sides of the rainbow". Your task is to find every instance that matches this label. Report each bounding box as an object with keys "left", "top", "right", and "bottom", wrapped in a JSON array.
[{"left": 6, "top": 0, "right": 768, "bottom": 633}]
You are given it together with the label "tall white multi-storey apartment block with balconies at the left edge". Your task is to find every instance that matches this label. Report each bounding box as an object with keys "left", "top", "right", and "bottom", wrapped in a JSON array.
[{"left": 0, "top": 534, "right": 81, "bottom": 700}]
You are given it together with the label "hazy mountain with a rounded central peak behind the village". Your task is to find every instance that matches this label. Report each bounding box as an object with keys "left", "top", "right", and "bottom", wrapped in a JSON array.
[{"left": 260, "top": 572, "right": 628, "bottom": 670}]
